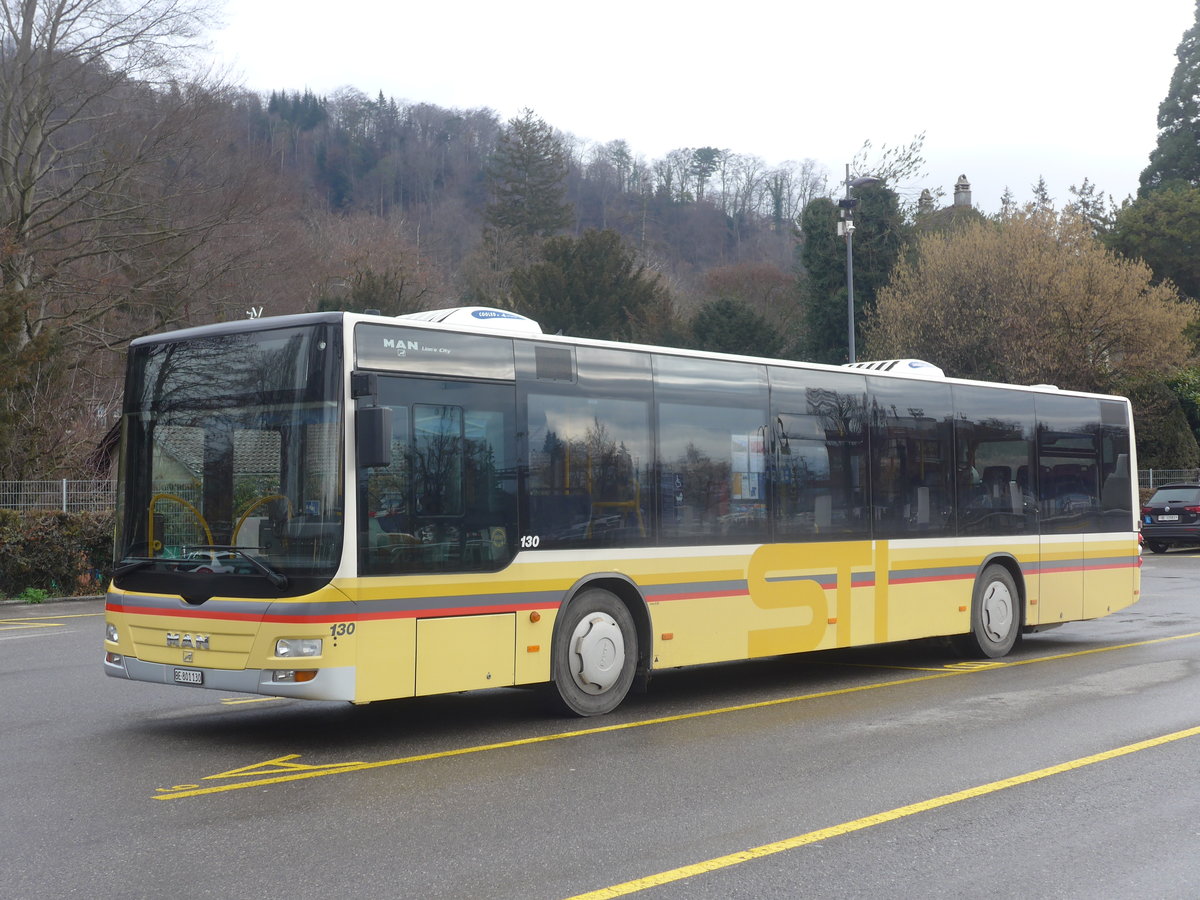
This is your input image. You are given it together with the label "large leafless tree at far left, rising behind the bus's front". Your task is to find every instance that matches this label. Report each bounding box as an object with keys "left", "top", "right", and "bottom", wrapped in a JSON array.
[{"left": 0, "top": 0, "right": 314, "bottom": 478}]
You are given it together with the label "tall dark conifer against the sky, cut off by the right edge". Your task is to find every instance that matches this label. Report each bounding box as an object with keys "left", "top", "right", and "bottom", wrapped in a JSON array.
[{"left": 1138, "top": 0, "right": 1200, "bottom": 197}]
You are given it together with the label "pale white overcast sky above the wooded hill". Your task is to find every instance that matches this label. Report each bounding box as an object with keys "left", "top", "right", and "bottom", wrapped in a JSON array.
[{"left": 204, "top": 0, "right": 1195, "bottom": 212}]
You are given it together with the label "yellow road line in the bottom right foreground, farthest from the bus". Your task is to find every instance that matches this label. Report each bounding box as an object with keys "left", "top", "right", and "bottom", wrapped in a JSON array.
[{"left": 569, "top": 726, "right": 1200, "bottom": 900}]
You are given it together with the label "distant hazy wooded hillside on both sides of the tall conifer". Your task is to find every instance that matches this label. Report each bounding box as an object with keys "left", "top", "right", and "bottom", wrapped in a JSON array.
[{"left": 259, "top": 89, "right": 828, "bottom": 292}]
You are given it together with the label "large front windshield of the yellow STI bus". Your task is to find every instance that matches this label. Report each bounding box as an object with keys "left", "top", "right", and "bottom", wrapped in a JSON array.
[{"left": 115, "top": 324, "right": 343, "bottom": 601}]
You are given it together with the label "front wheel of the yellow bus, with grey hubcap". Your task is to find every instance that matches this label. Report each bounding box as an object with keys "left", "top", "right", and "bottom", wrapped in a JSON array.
[{"left": 551, "top": 588, "right": 637, "bottom": 715}]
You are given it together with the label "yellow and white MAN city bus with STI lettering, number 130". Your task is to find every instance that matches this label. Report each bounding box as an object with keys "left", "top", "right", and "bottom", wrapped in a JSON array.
[{"left": 104, "top": 307, "right": 1140, "bottom": 715}]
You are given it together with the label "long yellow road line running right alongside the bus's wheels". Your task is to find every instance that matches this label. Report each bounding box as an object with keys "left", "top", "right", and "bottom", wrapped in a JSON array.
[{"left": 155, "top": 631, "right": 1200, "bottom": 800}]
